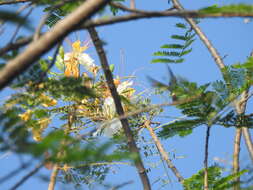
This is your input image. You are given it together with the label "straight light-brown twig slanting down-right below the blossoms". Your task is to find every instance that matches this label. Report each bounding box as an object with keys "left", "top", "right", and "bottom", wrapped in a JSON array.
[{"left": 144, "top": 120, "right": 184, "bottom": 184}]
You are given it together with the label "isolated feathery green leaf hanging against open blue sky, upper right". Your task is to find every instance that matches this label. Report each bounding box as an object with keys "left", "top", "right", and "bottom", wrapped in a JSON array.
[{"left": 152, "top": 23, "right": 195, "bottom": 63}]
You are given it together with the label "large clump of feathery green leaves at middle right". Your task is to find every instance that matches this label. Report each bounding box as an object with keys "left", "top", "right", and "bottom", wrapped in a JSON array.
[{"left": 152, "top": 67, "right": 253, "bottom": 138}]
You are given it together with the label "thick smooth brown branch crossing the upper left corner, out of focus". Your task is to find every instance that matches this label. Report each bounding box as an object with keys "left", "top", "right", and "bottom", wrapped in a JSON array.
[{"left": 0, "top": 0, "right": 109, "bottom": 89}]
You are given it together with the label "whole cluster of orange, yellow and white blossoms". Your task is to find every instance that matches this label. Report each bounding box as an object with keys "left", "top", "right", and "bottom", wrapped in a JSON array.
[{"left": 19, "top": 40, "right": 138, "bottom": 141}]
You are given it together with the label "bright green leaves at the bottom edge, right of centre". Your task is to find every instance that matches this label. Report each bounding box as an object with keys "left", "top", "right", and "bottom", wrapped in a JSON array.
[{"left": 184, "top": 166, "right": 247, "bottom": 190}]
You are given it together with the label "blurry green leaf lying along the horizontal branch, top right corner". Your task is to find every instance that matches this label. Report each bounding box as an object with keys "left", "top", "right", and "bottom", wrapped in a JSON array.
[{"left": 199, "top": 3, "right": 253, "bottom": 14}]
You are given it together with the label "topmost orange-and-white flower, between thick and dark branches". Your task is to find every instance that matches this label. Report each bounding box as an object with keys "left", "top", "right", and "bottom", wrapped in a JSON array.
[{"left": 64, "top": 40, "right": 98, "bottom": 78}]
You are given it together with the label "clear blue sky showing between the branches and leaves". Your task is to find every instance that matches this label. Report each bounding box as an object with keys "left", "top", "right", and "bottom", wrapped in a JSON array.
[{"left": 0, "top": 0, "right": 253, "bottom": 190}]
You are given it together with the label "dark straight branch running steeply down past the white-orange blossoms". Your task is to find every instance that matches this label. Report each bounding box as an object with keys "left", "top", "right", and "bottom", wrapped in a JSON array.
[{"left": 88, "top": 28, "right": 151, "bottom": 190}]
